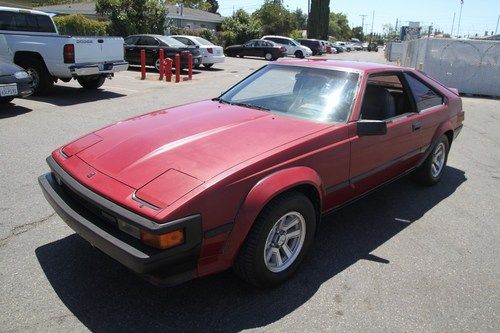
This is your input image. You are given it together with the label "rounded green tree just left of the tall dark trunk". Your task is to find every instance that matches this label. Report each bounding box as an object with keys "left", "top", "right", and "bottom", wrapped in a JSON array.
[{"left": 252, "top": 0, "right": 297, "bottom": 36}]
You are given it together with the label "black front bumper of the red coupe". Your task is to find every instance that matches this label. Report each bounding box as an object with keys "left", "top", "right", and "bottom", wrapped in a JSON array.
[{"left": 38, "top": 157, "right": 202, "bottom": 285}]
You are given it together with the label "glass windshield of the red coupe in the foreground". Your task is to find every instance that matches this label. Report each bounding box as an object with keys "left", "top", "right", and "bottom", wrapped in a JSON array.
[{"left": 218, "top": 65, "right": 359, "bottom": 123}]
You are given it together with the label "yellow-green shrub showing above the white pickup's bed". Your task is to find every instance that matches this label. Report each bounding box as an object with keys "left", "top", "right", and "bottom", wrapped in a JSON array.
[{"left": 54, "top": 14, "right": 109, "bottom": 36}]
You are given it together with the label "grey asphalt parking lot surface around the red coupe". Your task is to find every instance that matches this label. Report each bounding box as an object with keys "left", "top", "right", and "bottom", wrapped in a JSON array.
[{"left": 0, "top": 52, "right": 500, "bottom": 332}]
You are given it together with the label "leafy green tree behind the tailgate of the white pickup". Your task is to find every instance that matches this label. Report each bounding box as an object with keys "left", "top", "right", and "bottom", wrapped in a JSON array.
[{"left": 96, "top": 0, "right": 166, "bottom": 36}]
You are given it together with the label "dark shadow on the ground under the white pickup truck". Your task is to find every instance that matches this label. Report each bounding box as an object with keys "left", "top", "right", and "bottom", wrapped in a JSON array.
[{"left": 28, "top": 82, "right": 126, "bottom": 106}]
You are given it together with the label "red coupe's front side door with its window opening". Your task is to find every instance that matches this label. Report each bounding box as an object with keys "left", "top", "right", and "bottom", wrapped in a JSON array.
[{"left": 349, "top": 72, "right": 423, "bottom": 196}]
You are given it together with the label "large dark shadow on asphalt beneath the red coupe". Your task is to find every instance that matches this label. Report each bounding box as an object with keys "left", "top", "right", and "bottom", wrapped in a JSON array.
[{"left": 35, "top": 167, "right": 466, "bottom": 332}]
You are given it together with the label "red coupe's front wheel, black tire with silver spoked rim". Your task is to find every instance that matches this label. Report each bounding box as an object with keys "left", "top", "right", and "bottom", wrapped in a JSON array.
[{"left": 233, "top": 192, "right": 316, "bottom": 288}]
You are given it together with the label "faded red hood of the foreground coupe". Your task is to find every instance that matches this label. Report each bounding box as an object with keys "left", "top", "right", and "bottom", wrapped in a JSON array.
[{"left": 72, "top": 101, "right": 327, "bottom": 189}]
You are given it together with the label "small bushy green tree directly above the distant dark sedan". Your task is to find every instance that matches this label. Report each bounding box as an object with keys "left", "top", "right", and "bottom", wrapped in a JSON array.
[{"left": 221, "top": 9, "right": 261, "bottom": 46}]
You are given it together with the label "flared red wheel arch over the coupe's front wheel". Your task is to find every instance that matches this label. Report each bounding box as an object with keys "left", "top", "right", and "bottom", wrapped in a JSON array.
[{"left": 224, "top": 167, "right": 325, "bottom": 267}]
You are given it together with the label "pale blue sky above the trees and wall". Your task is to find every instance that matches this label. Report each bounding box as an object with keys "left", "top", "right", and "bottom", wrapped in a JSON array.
[{"left": 218, "top": 0, "right": 500, "bottom": 36}]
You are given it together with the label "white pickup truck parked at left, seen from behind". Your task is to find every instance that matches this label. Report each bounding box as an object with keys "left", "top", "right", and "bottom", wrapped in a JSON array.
[{"left": 0, "top": 7, "right": 128, "bottom": 95}]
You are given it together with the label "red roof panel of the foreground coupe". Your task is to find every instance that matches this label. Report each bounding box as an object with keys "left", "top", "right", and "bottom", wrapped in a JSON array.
[{"left": 277, "top": 59, "right": 406, "bottom": 72}]
